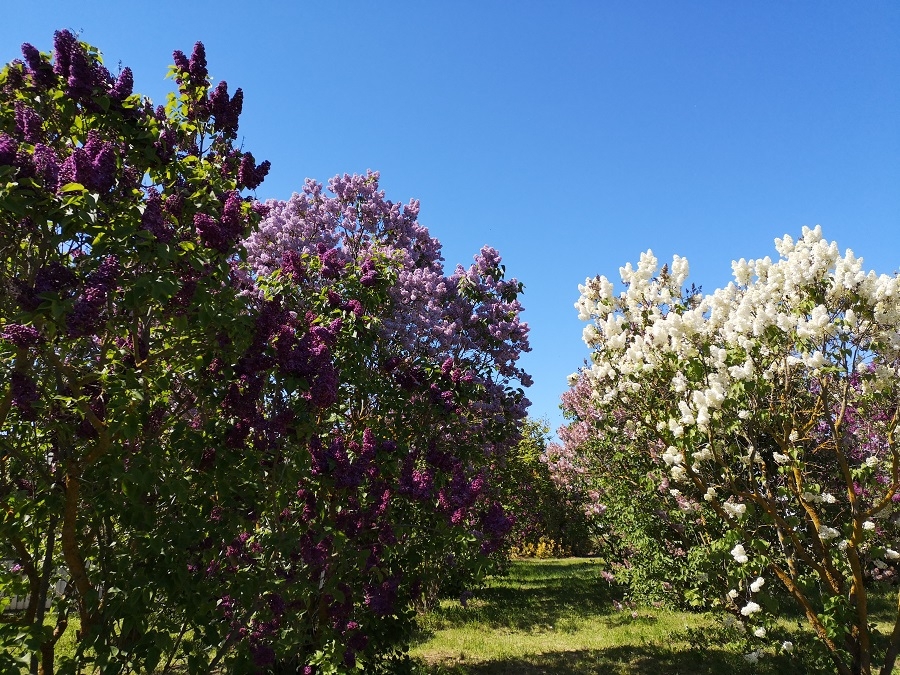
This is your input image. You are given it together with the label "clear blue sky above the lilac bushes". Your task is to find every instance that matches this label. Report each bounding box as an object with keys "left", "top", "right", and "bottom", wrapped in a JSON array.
[{"left": 0, "top": 0, "right": 900, "bottom": 438}]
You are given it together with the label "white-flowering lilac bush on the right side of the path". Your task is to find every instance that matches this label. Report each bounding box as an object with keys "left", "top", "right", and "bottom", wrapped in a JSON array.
[{"left": 568, "top": 227, "right": 900, "bottom": 674}]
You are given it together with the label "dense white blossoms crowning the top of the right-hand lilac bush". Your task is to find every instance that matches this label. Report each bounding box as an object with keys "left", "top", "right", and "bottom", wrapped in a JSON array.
[{"left": 575, "top": 227, "right": 900, "bottom": 431}]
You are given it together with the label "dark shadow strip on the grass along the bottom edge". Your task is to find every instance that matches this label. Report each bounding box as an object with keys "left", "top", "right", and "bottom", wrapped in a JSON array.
[{"left": 414, "top": 646, "right": 798, "bottom": 675}]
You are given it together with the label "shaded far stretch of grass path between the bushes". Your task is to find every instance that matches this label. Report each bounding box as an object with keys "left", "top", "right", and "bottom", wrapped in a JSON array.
[{"left": 422, "top": 560, "right": 620, "bottom": 639}]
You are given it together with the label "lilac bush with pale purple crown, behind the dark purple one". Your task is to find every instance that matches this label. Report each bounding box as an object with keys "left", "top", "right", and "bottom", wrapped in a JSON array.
[{"left": 245, "top": 173, "right": 530, "bottom": 616}]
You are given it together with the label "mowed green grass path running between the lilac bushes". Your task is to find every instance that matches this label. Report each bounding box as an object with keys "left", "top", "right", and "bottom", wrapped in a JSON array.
[{"left": 411, "top": 558, "right": 797, "bottom": 675}]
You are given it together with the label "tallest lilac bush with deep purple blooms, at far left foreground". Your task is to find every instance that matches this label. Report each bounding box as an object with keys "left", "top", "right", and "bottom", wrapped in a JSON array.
[{"left": 0, "top": 31, "right": 278, "bottom": 674}]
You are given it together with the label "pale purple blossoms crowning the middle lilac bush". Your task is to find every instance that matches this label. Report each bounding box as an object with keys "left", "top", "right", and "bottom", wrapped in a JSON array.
[{"left": 244, "top": 172, "right": 531, "bottom": 417}]
